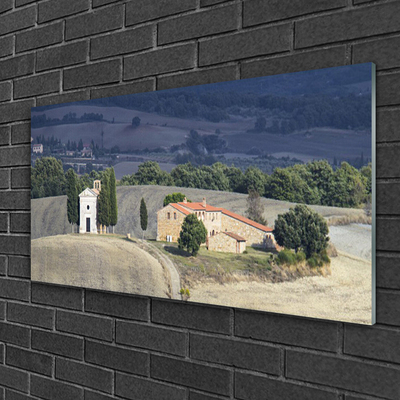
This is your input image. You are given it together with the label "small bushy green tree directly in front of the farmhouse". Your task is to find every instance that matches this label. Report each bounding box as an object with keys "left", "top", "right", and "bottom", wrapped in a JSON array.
[{"left": 178, "top": 214, "right": 207, "bottom": 256}]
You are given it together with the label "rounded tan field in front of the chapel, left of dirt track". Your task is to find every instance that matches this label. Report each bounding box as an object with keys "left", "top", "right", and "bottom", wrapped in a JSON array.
[{"left": 31, "top": 234, "right": 170, "bottom": 297}]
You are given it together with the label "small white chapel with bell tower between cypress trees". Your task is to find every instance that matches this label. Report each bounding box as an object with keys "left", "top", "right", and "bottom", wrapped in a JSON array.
[{"left": 79, "top": 180, "right": 101, "bottom": 234}]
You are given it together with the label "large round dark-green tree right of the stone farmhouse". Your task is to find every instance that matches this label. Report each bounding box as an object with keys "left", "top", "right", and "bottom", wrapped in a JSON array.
[{"left": 274, "top": 204, "right": 329, "bottom": 258}]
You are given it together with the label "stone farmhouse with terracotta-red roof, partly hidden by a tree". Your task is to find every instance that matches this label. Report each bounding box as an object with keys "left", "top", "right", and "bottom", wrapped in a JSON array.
[{"left": 157, "top": 198, "right": 276, "bottom": 253}]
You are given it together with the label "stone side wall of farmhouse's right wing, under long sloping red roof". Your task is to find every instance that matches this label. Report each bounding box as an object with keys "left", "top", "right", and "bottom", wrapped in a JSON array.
[{"left": 221, "top": 214, "right": 274, "bottom": 248}]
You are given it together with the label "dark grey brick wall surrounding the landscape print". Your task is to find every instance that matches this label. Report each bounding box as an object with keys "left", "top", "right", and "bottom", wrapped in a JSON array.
[{"left": 0, "top": 0, "right": 400, "bottom": 400}]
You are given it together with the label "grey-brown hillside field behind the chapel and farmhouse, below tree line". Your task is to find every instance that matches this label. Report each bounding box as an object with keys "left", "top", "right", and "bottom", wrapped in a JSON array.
[{"left": 32, "top": 186, "right": 363, "bottom": 239}]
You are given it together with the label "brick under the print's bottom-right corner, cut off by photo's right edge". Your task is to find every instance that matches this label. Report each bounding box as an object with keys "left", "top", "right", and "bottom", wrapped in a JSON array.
[{"left": 344, "top": 325, "right": 400, "bottom": 363}]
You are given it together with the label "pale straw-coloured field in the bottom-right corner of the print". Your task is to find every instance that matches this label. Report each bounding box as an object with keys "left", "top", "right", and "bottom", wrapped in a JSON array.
[{"left": 190, "top": 253, "right": 372, "bottom": 324}]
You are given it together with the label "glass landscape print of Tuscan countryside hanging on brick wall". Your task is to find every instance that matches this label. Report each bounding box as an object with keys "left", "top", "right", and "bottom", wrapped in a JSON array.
[{"left": 31, "top": 63, "right": 375, "bottom": 324}]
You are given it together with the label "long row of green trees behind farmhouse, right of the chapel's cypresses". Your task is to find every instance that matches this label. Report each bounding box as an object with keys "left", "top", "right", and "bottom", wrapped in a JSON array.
[{"left": 119, "top": 160, "right": 372, "bottom": 207}]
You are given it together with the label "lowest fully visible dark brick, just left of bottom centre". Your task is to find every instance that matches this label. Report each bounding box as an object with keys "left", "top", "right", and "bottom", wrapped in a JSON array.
[{"left": 150, "top": 355, "right": 231, "bottom": 396}]
